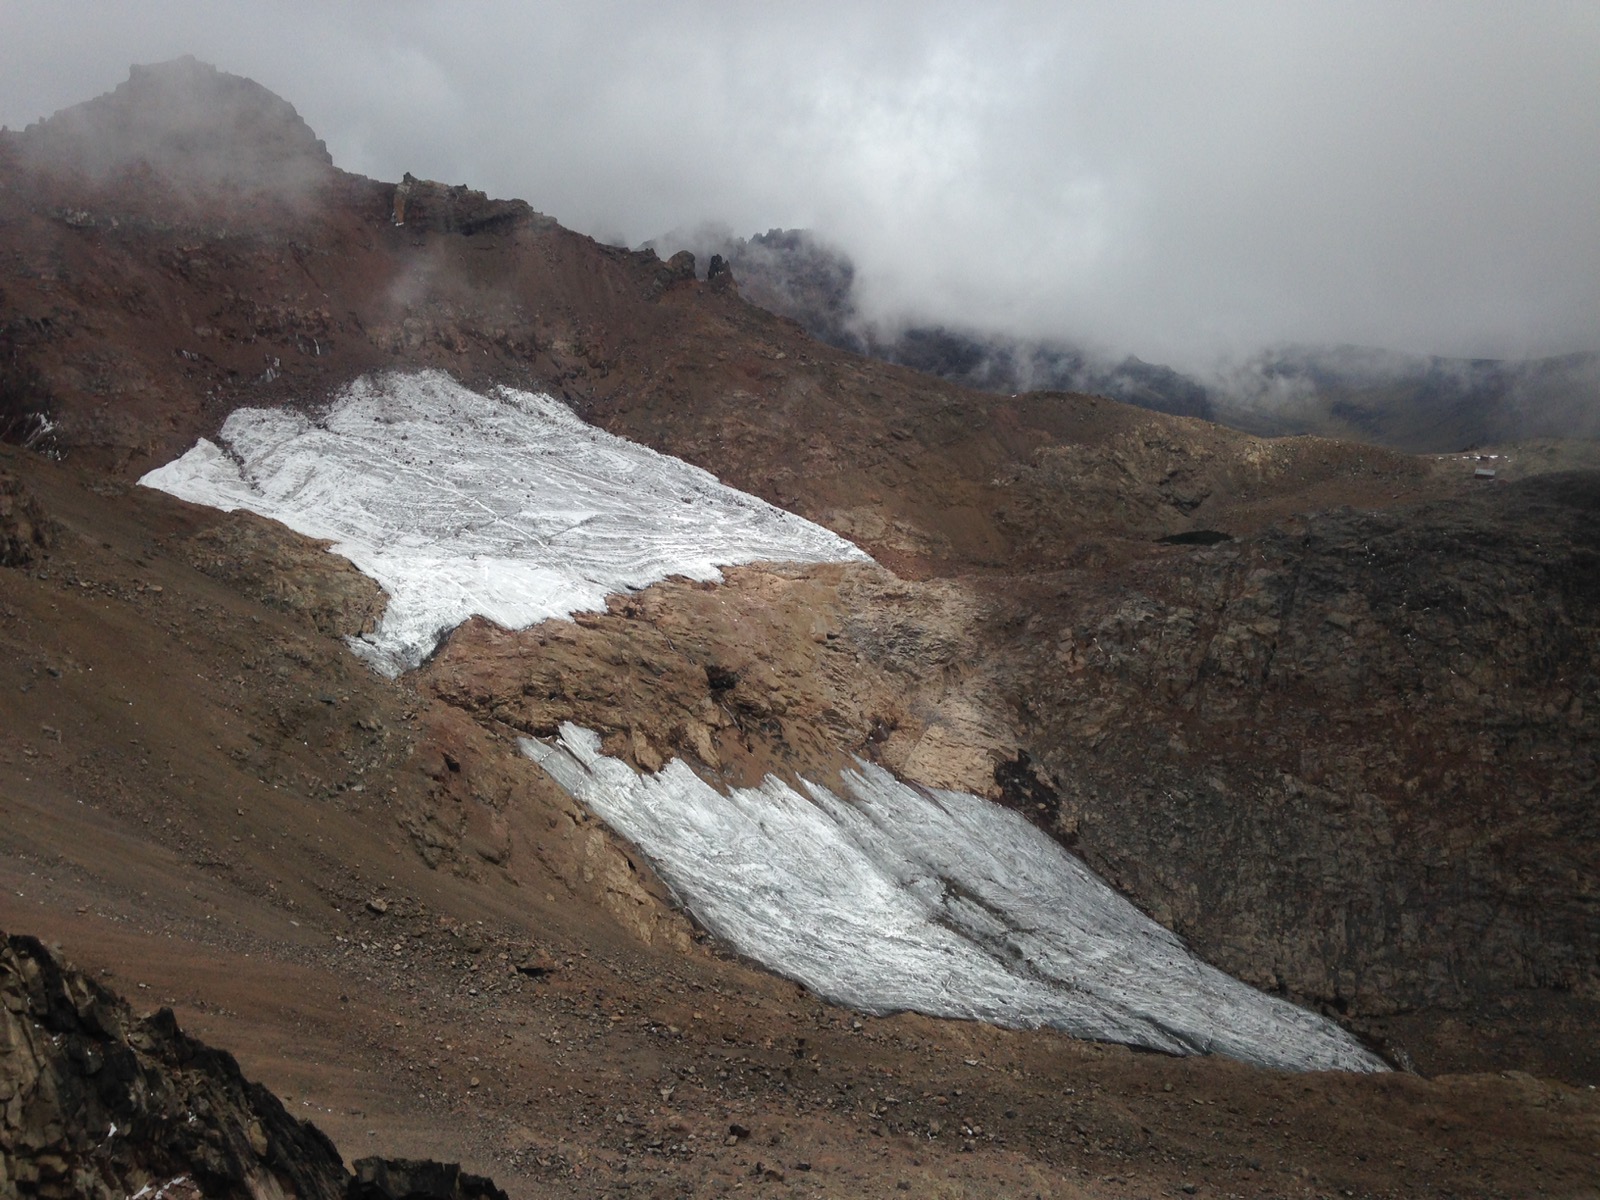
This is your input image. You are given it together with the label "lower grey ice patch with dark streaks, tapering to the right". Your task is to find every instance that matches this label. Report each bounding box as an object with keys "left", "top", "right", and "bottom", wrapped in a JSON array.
[{"left": 520, "top": 725, "right": 1384, "bottom": 1070}]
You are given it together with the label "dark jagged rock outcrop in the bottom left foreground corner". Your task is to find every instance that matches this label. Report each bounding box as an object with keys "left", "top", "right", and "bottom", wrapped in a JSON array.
[{"left": 0, "top": 934, "right": 504, "bottom": 1200}]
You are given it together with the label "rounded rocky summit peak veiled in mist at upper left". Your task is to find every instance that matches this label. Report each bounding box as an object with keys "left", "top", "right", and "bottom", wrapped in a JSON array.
[{"left": 22, "top": 54, "right": 333, "bottom": 190}]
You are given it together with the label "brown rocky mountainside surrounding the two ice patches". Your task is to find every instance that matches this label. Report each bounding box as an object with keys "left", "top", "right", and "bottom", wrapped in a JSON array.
[{"left": 0, "top": 58, "right": 1600, "bottom": 1195}]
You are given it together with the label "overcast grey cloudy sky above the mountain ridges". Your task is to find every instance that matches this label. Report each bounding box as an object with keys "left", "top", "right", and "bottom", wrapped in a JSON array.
[{"left": 0, "top": 0, "right": 1600, "bottom": 368}]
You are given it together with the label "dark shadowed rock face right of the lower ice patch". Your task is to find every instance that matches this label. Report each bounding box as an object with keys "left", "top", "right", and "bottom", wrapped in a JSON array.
[{"left": 1026, "top": 474, "right": 1600, "bottom": 1074}]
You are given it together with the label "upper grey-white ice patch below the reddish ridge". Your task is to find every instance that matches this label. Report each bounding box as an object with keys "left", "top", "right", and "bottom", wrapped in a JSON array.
[{"left": 139, "top": 371, "right": 867, "bottom": 675}]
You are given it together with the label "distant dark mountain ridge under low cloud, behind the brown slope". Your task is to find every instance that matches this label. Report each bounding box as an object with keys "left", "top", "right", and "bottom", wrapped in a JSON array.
[{"left": 645, "top": 227, "right": 1600, "bottom": 453}]
